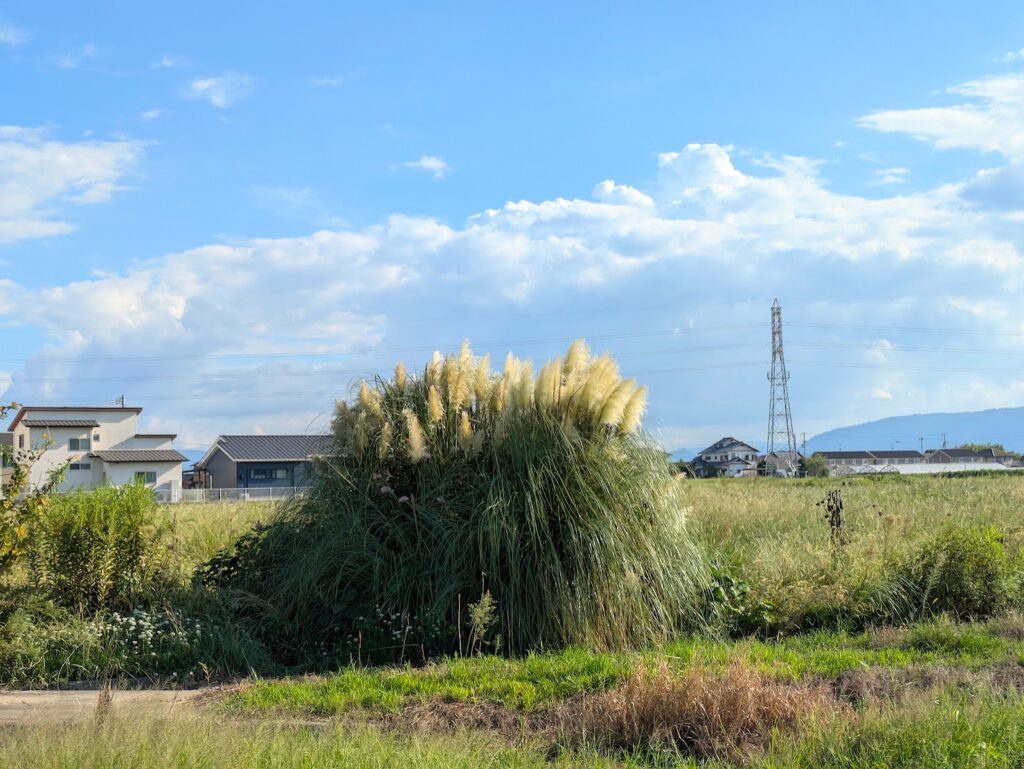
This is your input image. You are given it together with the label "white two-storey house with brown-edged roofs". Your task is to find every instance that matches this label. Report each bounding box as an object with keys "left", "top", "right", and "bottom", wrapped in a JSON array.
[{"left": 7, "top": 405, "right": 186, "bottom": 501}]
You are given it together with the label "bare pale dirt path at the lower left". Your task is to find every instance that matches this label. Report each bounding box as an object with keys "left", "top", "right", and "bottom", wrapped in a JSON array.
[{"left": 0, "top": 689, "right": 204, "bottom": 726}]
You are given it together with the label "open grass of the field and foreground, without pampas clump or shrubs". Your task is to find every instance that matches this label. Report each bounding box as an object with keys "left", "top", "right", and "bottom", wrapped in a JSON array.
[{"left": 0, "top": 475, "right": 1024, "bottom": 769}]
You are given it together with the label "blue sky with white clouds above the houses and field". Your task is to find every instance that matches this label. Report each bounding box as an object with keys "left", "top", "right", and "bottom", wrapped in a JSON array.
[{"left": 0, "top": 0, "right": 1024, "bottom": 451}]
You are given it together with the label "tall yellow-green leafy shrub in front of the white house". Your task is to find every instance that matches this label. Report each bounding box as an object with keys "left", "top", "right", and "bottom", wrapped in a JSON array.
[{"left": 26, "top": 484, "right": 164, "bottom": 612}]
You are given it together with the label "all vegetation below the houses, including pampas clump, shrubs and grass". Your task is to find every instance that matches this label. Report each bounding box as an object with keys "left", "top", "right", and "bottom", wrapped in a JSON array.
[{"left": 0, "top": 348, "right": 1024, "bottom": 767}]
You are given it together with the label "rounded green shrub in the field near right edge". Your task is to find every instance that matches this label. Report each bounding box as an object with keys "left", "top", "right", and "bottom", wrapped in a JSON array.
[{"left": 896, "top": 526, "right": 1015, "bottom": 618}]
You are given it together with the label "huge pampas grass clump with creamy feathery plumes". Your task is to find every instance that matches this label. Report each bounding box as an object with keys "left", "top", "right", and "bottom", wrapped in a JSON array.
[{"left": 202, "top": 342, "right": 702, "bottom": 659}]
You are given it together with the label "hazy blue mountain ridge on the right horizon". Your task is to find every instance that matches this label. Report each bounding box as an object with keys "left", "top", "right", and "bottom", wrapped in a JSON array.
[{"left": 807, "top": 408, "right": 1024, "bottom": 454}]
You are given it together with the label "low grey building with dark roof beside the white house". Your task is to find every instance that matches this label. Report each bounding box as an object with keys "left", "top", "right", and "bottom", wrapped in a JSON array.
[{"left": 190, "top": 435, "right": 334, "bottom": 488}]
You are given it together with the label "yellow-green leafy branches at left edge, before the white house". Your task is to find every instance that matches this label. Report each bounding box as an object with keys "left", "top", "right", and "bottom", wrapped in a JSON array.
[{"left": 0, "top": 403, "right": 67, "bottom": 574}]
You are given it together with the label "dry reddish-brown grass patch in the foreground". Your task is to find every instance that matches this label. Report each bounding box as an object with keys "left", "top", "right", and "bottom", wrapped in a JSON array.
[{"left": 559, "top": 664, "right": 845, "bottom": 761}]
